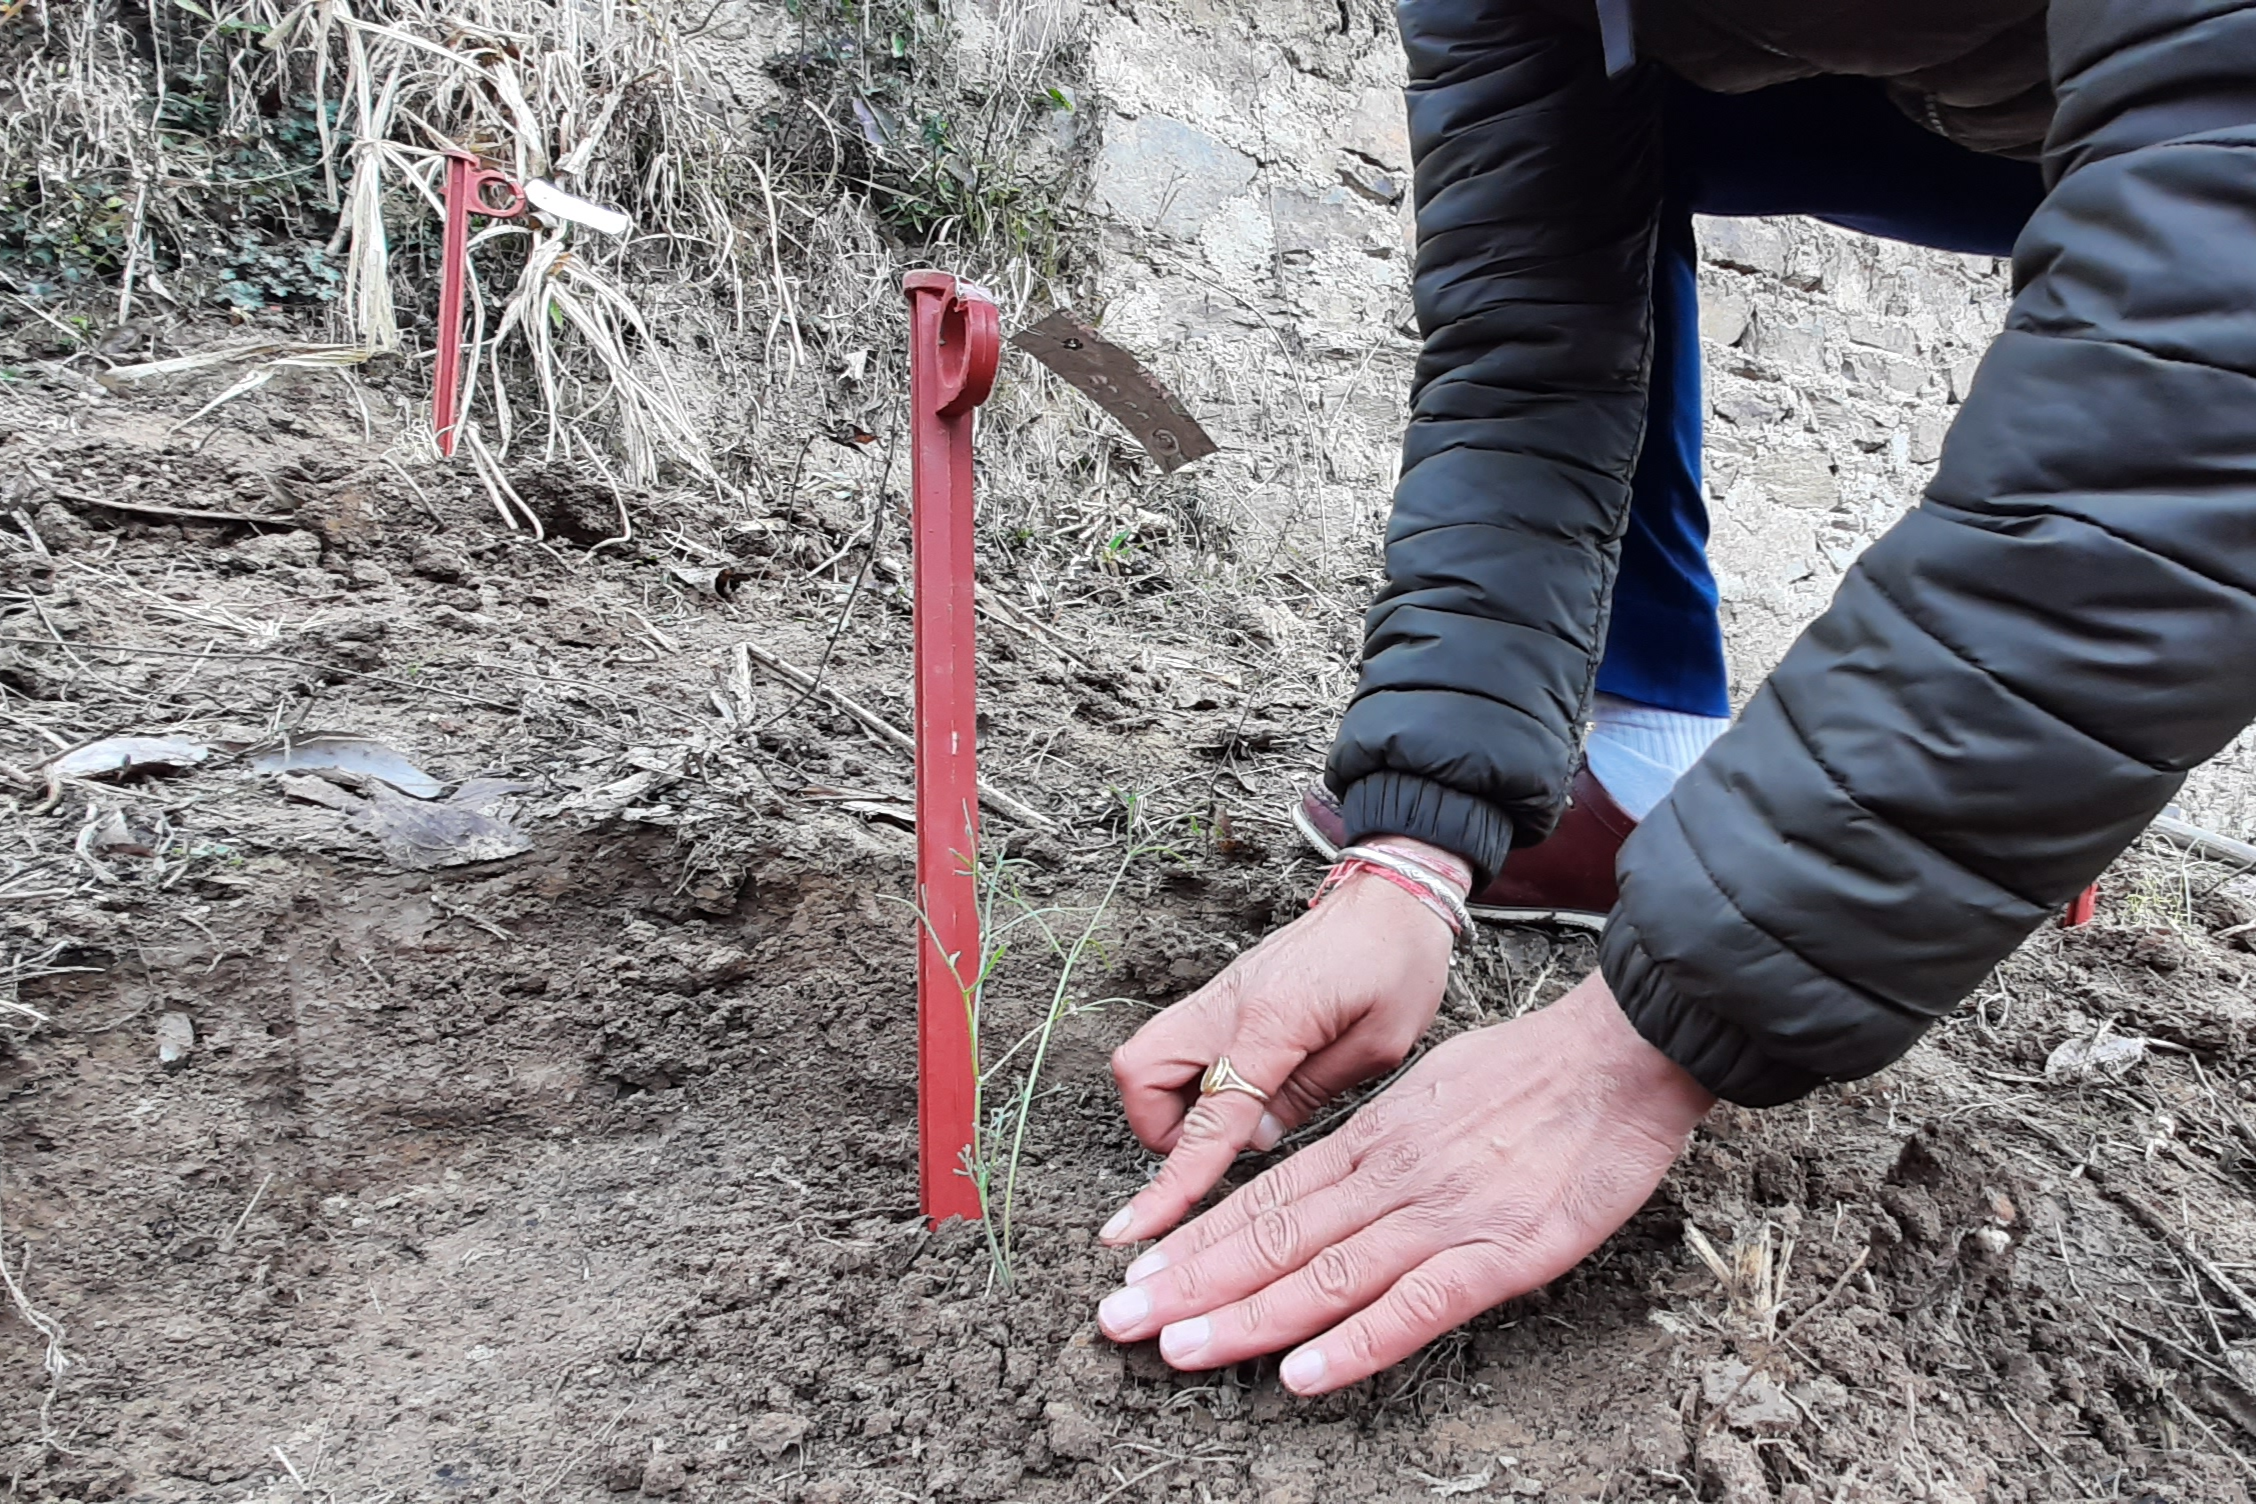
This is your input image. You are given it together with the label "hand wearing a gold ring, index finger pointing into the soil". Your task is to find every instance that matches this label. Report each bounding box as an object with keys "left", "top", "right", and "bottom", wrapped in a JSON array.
[{"left": 1101, "top": 847, "right": 1453, "bottom": 1245}]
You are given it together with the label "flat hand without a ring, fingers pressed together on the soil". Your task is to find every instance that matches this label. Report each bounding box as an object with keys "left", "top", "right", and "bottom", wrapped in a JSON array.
[{"left": 1096, "top": 974, "right": 1715, "bottom": 1394}]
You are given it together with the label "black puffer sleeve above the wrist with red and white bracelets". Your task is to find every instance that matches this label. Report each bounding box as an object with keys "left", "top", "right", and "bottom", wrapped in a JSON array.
[{"left": 1329, "top": 0, "right": 1660, "bottom": 875}]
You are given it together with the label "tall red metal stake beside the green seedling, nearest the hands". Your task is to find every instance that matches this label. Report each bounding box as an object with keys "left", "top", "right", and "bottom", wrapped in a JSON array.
[{"left": 902, "top": 271, "right": 1002, "bottom": 1224}]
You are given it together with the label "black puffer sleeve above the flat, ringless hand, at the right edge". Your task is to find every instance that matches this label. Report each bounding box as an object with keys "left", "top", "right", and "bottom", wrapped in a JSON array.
[{"left": 1602, "top": 0, "right": 2256, "bottom": 1105}]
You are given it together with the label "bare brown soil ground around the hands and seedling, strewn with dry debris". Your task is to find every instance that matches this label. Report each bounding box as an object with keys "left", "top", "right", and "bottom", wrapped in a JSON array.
[{"left": 0, "top": 378, "right": 2256, "bottom": 1504}]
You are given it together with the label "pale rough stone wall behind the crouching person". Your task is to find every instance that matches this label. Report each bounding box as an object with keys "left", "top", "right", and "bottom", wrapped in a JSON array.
[{"left": 1055, "top": 0, "right": 2256, "bottom": 834}]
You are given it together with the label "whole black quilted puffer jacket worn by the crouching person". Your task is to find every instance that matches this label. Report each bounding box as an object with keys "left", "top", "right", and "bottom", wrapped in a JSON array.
[{"left": 1329, "top": 0, "right": 2256, "bottom": 1105}]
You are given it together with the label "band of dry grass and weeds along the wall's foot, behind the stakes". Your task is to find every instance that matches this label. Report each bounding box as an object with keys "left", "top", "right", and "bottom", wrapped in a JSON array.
[{"left": 0, "top": 0, "right": 1401, "bottom": 721}]
